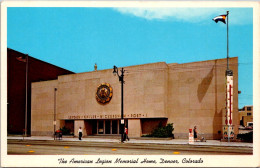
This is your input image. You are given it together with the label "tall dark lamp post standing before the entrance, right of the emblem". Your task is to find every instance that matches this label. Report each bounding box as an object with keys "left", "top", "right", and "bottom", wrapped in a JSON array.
[{"left": 113, "top": 65, "right": 125, "bottom": 142}]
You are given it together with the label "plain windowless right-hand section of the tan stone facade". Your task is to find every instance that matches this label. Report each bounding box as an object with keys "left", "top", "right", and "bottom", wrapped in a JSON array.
[{"left": 168, "top": 58, "right": 239, "bottom": 139}]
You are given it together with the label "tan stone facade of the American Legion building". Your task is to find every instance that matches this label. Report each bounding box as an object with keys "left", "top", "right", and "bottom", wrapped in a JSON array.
[{"left": 31, "top": 57, "right": 239, "bottom": 139}]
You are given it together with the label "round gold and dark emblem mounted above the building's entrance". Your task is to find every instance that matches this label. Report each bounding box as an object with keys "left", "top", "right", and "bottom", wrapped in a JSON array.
[{"left": 96, "top": 83, "right": 113, "bottom": 104}]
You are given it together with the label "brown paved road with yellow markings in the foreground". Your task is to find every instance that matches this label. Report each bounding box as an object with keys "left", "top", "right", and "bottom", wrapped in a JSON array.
[{"left": 7, "top": 140, "right": 252, "bottom": 155}]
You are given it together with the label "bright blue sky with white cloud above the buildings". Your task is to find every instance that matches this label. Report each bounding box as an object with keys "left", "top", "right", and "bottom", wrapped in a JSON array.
[{"left": 7, "top": 7, "right": 253, "bottom": 108}]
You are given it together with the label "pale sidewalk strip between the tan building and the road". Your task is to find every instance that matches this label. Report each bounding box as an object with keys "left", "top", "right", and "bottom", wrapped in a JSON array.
[{"left": 7, "top": 136, "right": 253, "bottom": 148}]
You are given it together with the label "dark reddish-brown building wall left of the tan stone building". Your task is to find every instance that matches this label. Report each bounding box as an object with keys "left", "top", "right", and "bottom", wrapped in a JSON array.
[{"left": 7, "top": 48, "right": 73, "bottom": 134}]
